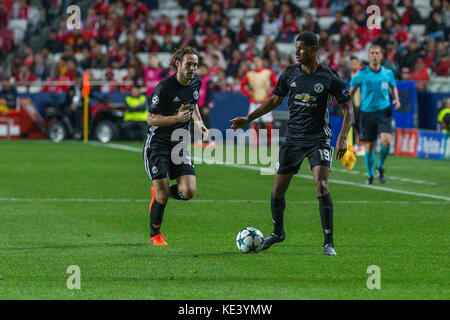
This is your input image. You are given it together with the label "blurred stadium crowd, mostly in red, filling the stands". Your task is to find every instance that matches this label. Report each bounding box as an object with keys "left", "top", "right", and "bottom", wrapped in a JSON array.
[{"left": 0, "top": 0, "right": 450, "bottom": 102}]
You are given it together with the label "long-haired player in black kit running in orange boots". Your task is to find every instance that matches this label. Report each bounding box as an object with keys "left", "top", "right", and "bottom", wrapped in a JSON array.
[{"left": 144, "top": 47, "right": 208, "bottom": 245}]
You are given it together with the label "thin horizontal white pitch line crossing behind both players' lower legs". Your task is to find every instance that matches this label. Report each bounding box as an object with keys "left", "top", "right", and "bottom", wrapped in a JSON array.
[{"left": 0, "top": 198, "right": 448, "bottom": 204}]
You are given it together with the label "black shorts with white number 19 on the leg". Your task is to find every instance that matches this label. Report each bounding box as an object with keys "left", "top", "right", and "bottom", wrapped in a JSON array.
[{"left": 276, "top": 141, "right": 334, "bottom": 174}]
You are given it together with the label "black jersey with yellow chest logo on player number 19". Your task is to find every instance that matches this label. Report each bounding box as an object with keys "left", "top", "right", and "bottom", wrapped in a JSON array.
[{"left": 273, "top": 64, "right": 351, "bottom": 144}]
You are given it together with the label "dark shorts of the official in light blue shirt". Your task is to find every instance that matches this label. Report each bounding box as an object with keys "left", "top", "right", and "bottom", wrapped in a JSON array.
[{"left": 359, "top": 107, "right": 392, "bottom": 142}]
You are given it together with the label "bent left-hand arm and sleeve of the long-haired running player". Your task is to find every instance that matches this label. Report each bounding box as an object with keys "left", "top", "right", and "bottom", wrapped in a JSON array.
[{"left": 147, "top": 83, "right": 191, "bottom": 127}]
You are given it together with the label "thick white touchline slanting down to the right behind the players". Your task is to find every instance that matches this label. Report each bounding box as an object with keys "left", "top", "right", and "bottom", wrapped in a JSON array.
[{"left": 90, "top": 142, "right": 450, "bottom": 201}]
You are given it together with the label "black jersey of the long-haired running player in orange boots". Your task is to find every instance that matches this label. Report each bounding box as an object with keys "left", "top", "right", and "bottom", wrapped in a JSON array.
[{"left": 148, "top": 73, "right": 202, "bottom": 145}]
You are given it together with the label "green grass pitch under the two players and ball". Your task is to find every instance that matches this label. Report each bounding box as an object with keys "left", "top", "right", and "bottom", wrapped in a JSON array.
[{"left": 0, "top": 140, "right": 450, "bottom": 299}]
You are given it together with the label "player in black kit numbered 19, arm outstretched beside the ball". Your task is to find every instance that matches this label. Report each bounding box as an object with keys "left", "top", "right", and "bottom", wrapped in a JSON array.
[{"left": 231, "top": 32, "right": 353, "bottom": 255}]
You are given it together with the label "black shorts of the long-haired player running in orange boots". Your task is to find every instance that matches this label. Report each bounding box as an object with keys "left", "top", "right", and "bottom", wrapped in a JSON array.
[{"left": 144, "top": 145, "right": 195, "bottom": 180}]
